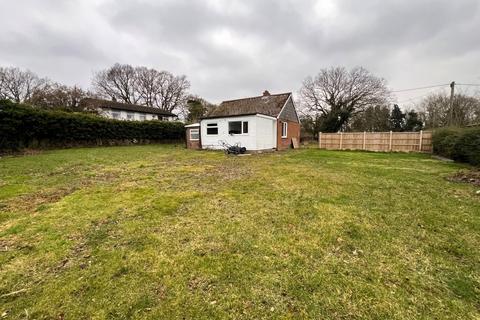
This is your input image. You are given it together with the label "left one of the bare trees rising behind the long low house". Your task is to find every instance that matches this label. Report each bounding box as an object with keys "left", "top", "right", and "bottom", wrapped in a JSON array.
[{"left": 93, "top": 63, "right": 139, "bottom": 104}]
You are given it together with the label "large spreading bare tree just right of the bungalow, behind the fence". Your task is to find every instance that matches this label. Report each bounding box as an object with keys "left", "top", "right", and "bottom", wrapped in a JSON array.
[{"left": 300, "top": 67, "right": 390, "bottom": 132}]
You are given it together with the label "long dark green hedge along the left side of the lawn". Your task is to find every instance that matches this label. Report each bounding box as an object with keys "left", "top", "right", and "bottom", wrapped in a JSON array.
[{"left": 0, "top": 100, "right": 185, "bottom": 151}]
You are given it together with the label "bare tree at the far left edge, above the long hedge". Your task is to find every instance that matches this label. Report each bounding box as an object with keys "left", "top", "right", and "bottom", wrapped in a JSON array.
[{"left": 0, "top": 67, "right": 48, "bottom": 102}]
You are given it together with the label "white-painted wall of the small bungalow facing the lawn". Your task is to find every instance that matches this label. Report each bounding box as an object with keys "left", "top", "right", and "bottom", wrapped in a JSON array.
[{"left": 200, "top": 114, "right": 277, "bottom": 151}]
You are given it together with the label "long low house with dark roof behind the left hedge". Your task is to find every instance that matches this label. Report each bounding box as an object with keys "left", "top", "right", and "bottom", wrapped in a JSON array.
[{"left": 80, "top": 98, "right": 177, "bottom": 121}]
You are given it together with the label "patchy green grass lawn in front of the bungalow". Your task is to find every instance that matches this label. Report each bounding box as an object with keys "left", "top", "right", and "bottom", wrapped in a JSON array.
[{"left": 0, "top": 146, "right": 480, "bottom": 319}]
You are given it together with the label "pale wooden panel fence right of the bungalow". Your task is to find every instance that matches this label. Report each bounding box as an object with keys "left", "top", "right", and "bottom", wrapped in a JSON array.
[{"left": 318, "top": 131, "right": 432, "bottom": 152}]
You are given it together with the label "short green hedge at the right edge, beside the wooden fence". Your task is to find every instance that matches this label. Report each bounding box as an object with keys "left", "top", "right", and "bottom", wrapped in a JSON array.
[{"left": 433, "top": 127, "right": 480, "bottom": 166}]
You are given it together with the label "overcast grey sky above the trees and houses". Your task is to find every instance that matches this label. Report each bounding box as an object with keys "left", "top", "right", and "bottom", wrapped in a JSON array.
[{"left": 0, "top": 0, "right": 480, "bottom": 102}]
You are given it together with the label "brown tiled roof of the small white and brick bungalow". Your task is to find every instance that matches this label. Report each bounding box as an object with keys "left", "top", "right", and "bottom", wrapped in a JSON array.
[{"left": 204, "top": 91, "right": 291, "bottom": 119}]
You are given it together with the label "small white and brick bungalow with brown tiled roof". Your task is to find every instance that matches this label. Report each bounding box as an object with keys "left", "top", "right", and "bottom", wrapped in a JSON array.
[{"left": 185, "top": 91, "right": 300, "bottom": 151}]
